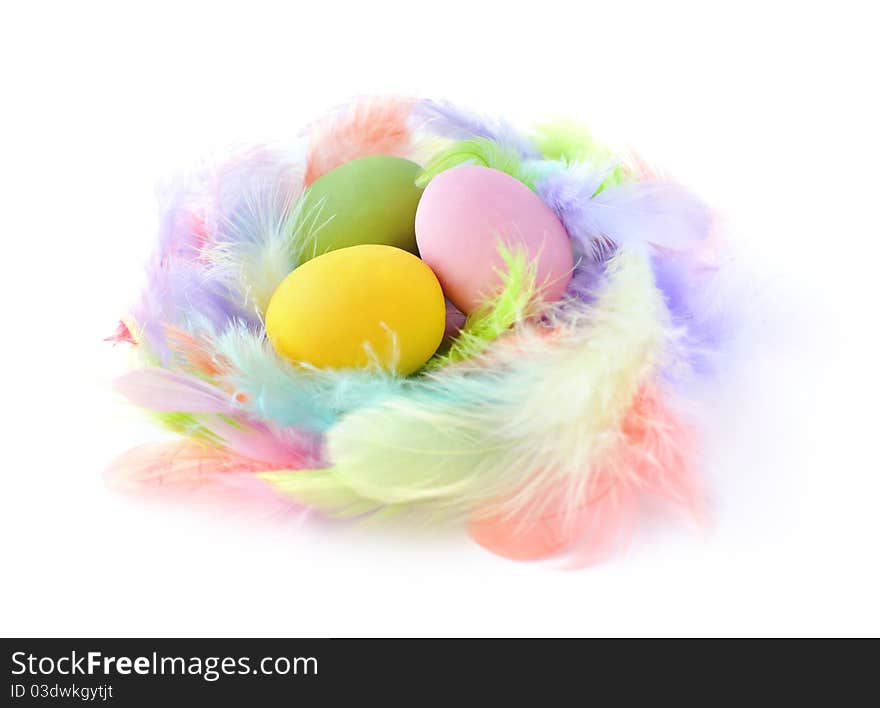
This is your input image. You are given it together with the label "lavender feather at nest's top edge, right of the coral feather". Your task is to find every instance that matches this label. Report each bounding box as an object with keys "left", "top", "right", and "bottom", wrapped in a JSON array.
[{"left": 413, "top": 99, "right": 539, "bottom": 158}]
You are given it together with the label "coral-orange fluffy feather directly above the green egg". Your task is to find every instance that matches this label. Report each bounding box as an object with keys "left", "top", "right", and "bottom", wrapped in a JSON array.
[{"left": 305, "top": 97, "right": 412, "bottom": 186}]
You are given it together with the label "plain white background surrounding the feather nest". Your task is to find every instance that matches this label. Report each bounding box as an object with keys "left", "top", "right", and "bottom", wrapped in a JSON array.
[{"left": 0, "top": 0, "right": 880, "bottom": 636}]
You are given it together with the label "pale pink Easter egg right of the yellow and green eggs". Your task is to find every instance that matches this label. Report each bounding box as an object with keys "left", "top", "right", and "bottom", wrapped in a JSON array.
[{"left": 416, "top": 165, "right": 574, "bottom": 313}]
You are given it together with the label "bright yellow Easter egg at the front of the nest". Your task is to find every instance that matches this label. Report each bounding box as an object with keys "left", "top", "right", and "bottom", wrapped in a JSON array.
[{"left": 266, "top": 245, "right": 446, "bottom": 375}]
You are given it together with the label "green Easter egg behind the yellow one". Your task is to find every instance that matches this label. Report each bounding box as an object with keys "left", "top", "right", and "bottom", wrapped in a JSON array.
[{"left": 294, "top": 155, "right": 422, "bottom": 263}]
